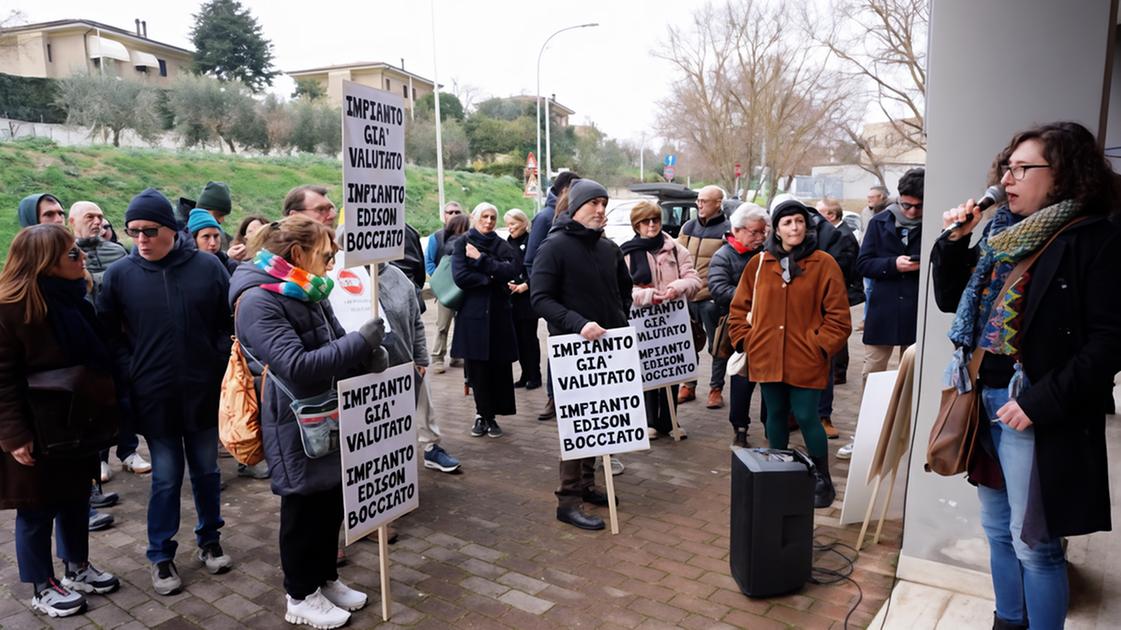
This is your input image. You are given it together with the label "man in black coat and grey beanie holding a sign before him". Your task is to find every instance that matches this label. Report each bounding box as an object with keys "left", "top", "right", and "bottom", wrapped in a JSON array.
[{"left": 529, "top": 179, "right": 631, "bottom": 529}]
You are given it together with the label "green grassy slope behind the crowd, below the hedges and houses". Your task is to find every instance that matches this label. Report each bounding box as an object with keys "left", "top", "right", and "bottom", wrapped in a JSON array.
[{"left": 0, "top": 139, "right": 532, "bottom": 260}]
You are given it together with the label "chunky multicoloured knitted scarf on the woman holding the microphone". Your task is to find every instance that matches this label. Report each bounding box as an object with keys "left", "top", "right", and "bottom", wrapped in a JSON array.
[{"left": 948, "top": 200, "right": 1080, "bottom": 391}]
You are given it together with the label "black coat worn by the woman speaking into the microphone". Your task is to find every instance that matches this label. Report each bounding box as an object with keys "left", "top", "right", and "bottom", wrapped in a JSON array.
[{"left": 932, "top": 212, "right": 1121, "bottom": 537}]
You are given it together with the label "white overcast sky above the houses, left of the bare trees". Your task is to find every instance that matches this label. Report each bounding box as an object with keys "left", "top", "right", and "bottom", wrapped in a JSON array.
[{"left": 10, "top": 0, "right": 717, "bottom": 143}]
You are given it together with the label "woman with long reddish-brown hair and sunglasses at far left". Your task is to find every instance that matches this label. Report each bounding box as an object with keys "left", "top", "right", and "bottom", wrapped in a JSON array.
[{"left": 0, "top": 224, "right": 120, "bottom": 617}]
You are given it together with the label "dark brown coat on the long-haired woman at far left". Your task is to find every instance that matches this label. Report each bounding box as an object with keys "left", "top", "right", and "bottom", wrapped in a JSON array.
[{"left": 0, "top": 304, "right": 98, "bottom": 510}]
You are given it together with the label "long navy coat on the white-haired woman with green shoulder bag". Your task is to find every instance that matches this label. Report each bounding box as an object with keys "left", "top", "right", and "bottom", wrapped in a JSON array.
[{"left": 452, "top": 229, "right": 522, "bottom": 362}]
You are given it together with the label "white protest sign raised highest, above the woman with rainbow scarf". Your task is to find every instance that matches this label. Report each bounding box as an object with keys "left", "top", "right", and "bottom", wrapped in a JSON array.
[{"left": 342, "top": 81, "right": 405, "bottom": 268}]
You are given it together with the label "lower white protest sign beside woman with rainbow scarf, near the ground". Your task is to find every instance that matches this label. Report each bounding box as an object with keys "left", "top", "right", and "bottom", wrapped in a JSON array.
[{"left": 339, "top": 363, "right": 420, "bottom": 545}]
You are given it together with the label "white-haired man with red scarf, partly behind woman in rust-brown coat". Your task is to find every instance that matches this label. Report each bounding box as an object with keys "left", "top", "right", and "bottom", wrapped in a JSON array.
[{"left": 708, "top": 203, "right": 770, "bottom": 448}]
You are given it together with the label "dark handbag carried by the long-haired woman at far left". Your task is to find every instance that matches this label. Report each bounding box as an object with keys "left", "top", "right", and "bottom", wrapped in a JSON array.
[{"left": 27, "top": 365, "right": 120, "bottom": 458}]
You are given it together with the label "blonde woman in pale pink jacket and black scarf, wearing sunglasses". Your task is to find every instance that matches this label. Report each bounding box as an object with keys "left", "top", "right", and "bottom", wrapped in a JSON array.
[{"left": 620, "top": 201, "right": 702, "bottom": 439}]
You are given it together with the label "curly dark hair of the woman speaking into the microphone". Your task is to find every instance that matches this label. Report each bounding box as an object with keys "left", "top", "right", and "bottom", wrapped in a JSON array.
[{"left": 989, "top": 121, "right": 1114, "bottom": 214}]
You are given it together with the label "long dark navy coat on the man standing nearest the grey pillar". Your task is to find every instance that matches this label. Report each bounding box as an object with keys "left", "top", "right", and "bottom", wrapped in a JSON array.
[{"left": 856, "top": 212, "right": 923, "bottom": 345}]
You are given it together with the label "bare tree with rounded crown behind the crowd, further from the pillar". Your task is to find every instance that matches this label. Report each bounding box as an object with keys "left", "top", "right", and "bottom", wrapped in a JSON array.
[{"left": 657, "top": 0, "right": 859, "bottom": 196}]
